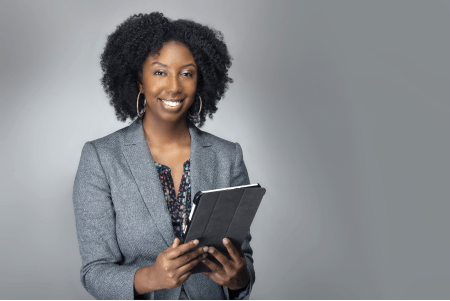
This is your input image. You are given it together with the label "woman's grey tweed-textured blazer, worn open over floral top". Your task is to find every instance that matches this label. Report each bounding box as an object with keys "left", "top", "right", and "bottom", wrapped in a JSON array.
[{"left": 73, "top": 118, "right": 255, "bottom": 300}]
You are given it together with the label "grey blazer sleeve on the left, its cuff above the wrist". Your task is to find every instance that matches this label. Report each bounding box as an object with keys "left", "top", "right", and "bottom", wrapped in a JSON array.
[{"left": 72, "top": 142, "right": 139, "bottom": 300}]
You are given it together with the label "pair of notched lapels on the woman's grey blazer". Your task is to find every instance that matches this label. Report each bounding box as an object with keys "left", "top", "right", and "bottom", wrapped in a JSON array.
[{"left": 122, "top": 118, "right": 217, "bottom": 246}]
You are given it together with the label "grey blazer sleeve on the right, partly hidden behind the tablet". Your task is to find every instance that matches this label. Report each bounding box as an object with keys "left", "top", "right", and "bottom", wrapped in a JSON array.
[{"left": 224, "top": 142, "right": 255, "bottom": 300}]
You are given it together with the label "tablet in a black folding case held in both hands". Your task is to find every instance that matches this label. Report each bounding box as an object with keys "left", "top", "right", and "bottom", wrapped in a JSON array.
[{"left": 183, "top": 184, "right": 266, "bottom": 274}]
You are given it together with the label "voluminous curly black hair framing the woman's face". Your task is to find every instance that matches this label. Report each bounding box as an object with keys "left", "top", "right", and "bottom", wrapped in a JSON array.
[{"left": 100, "top": 12, "right": 233, "bottom": 127}]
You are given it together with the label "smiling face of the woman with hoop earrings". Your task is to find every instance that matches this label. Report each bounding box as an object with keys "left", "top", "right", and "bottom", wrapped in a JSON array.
[{"left": 138, "top": 41, "right": 197, "bottom": 121}]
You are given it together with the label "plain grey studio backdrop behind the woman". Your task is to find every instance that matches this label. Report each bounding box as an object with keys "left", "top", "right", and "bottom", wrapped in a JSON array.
[{"left": 0, "top": 1, "right": 450, "bottom": 299}]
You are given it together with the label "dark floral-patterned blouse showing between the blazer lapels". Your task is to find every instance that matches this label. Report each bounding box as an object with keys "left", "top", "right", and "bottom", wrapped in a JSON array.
[{"left": 155, "top": 160, "right": 191, "bottom": 240}]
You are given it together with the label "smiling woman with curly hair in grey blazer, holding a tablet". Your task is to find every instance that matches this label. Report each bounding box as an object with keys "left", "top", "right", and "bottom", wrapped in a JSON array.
[{"left": 73, "top": 13, "right": 255, "bottom": 299}]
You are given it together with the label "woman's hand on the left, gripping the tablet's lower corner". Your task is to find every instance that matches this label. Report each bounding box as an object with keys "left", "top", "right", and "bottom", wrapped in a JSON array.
[{"left": 151, "top": 238, "right": 208, "bottom": 289}]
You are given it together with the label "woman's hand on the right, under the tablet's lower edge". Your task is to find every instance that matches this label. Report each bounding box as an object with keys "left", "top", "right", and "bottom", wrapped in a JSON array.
[{"left": 202, "top": 238, "right": 250, "bottom": 290}]
